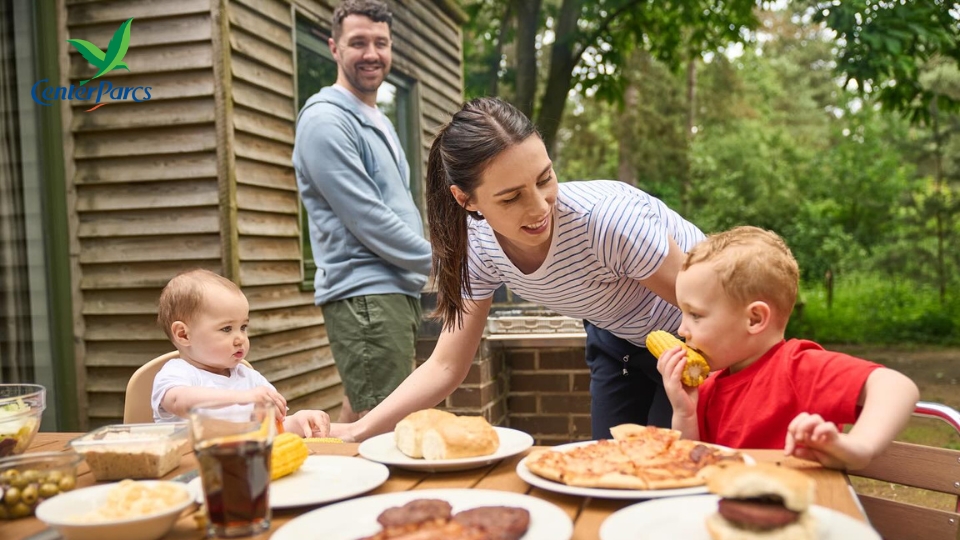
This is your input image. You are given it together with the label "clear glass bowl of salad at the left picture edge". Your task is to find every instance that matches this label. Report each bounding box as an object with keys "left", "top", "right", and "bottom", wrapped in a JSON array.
[{"left": 0, "top": 384, "right": 47, "bottom": 458}]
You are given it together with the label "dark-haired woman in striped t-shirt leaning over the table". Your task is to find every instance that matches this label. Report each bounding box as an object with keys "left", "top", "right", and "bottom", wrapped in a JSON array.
[{"left": 332, "top": 98, "right": 703, "bottom": 440}]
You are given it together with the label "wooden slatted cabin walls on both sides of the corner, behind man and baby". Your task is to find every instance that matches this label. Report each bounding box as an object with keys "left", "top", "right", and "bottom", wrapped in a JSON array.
[{"left": 61, "top": 0, "right": 463, "bottom": 427}]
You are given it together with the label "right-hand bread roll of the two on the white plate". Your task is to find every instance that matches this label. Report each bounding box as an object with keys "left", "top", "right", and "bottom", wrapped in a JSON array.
[{"left": 423, "top": 416, "right": 500, "bottom": 459}]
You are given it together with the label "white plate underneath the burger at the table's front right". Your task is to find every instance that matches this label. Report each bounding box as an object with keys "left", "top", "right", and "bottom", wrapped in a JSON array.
[{"left": 600, "top": 495, "right": 880, "bottom": 540}]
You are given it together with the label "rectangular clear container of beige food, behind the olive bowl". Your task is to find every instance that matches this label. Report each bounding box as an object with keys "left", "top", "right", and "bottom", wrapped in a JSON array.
[{"left": 70, "top": 422, "right": 188, "bottom": 482}]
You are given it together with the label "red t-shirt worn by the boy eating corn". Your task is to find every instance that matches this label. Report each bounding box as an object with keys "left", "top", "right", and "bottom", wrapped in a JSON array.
[{"left": 697, "top": 339, "right": 883, "bottom": 449}]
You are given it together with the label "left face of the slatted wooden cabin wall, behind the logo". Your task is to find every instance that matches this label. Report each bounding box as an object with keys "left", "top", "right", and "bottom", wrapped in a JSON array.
[{"left": 68, "top": 0, "right": 221, "bottom": 427}]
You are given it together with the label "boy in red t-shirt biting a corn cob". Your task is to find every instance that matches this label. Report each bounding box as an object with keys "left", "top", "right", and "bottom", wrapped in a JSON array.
[{"left": 657, "top": 227, "right": 919, "bottom": 469}]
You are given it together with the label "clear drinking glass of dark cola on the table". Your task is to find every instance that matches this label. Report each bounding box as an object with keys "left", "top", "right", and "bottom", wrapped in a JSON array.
[{"left": 190, "top": 402, "right": 277, "bottom": 538}]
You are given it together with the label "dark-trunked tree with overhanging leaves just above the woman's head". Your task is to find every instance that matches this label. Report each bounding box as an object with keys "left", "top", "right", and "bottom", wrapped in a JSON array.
[{"left": 466, "top": 0, "right": 757, "bottom": 154}]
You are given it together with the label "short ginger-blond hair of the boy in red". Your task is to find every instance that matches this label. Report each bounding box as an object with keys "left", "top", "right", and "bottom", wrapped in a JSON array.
[{"left": 683, "top": 226, "right": 800, "bottom": 325}]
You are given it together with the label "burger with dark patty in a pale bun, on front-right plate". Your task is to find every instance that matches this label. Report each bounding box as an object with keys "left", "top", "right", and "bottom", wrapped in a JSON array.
[{"left": 707, "top": 463, "right": 817, "bottom": 540}]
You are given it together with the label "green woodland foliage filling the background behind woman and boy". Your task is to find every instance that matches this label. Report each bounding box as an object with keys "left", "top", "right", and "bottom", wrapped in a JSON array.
[{"left": 464, "top": 0, "right": 960, "bottom": 344}]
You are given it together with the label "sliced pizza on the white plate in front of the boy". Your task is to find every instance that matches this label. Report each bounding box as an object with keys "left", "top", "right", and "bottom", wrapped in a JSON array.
[{"left": 526, "top": 424, "right": 743, "bottom": 490}]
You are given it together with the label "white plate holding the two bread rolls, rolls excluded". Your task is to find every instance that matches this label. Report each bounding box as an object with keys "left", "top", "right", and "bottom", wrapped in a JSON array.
[{"left": 359, "top": 427, "right": 533, "bottom": 472}]
